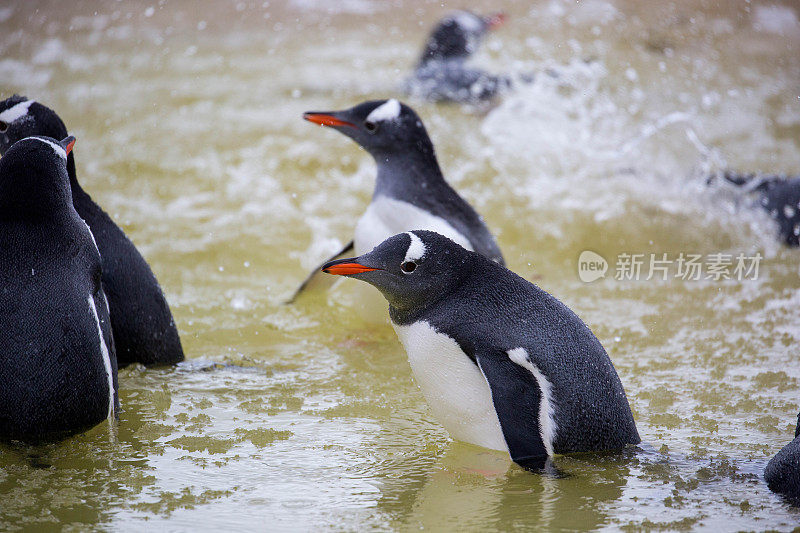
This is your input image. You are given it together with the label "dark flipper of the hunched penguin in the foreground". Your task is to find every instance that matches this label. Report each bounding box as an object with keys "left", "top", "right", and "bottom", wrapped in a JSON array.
[{"left": 475, "top": 350, "right": 549, "bottom": 469}]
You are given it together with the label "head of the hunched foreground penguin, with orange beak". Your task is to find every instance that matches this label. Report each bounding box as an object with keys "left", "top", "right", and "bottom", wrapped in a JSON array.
[{"left": 322, "top": 230, "right": 470, "bottom": 313}]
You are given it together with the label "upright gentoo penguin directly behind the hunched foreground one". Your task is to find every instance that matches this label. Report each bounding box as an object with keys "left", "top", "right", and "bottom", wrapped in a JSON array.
[{"left": 292, "top": 99, "right": 503, "bottom": 299}]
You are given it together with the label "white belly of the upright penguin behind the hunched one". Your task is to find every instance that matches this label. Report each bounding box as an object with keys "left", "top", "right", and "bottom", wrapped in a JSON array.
[{"left": 354, "top": 196, "right": 472, "bottom": 255}]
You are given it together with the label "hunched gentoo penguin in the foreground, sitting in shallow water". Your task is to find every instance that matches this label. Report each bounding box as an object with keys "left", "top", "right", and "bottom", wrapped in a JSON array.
[{"left": 322, "top": 230, "right": 640, "bottom": 466}]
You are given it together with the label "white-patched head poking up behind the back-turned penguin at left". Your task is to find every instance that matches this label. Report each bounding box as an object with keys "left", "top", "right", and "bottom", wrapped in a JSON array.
[{"left": 0, "top": 94, "right": 67, "bottom": 155}]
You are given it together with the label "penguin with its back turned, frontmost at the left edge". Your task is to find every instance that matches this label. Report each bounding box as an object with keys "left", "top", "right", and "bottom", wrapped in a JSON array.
[{"left": 0, "top": 137, "right": 118, "bottom": 441}]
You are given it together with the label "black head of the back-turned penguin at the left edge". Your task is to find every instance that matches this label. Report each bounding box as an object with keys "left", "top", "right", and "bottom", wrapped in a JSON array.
[{"left": 0, "top": 136, "right": 75, "bottom": 220}]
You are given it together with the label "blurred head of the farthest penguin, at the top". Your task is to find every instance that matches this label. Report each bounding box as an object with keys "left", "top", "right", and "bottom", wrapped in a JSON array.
[{"left": 420, "top": 11, "right": 505, "bottom": 64}]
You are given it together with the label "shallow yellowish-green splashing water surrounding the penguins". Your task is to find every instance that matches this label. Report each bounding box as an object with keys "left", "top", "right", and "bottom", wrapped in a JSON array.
[{"left": 0, "top": 0, "right": 800, "bottom": 531}]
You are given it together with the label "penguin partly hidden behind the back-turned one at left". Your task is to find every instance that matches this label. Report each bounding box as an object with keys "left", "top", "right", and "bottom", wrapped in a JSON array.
[{"left": 0, "top": 95, "right": 183, "bottom": 368}]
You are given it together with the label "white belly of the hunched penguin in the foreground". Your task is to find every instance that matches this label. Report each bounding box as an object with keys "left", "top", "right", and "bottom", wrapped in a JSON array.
[{"left": 394, "top": 321, "right": 508, "bottom": 452}]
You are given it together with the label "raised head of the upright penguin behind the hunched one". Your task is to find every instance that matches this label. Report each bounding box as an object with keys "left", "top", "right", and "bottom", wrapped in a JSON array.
[{"left": 303, "top": 98, "right": 433, "bottom": 161}]
